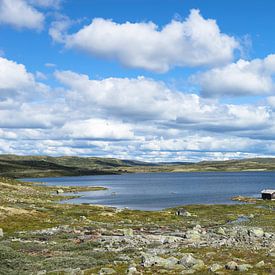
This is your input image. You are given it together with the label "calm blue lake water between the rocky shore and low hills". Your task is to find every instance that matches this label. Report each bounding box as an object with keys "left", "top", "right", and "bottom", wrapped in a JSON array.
[{"left": 24, "top": 172, "right": 275, "bottom": 210}]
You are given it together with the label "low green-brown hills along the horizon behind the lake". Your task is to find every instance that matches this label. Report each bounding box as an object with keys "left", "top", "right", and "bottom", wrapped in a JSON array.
[{"left": 0, "top": 155, "right": 275, "bottom": 178}]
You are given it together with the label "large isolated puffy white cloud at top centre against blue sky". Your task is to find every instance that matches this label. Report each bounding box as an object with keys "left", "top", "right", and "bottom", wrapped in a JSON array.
[{"left": 50, "top": 10, "right": 240, "bottom": 72}]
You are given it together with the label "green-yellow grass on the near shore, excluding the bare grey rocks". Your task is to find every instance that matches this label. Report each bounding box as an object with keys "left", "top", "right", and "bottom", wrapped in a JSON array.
[{"left": 0, "top": 178, "right": 275, "bottom": 275}]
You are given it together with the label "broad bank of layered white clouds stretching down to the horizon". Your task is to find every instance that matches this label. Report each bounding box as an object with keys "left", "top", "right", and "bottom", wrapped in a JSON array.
[{"left": 0, "top": 58, "right": 275, "bottom": 161}]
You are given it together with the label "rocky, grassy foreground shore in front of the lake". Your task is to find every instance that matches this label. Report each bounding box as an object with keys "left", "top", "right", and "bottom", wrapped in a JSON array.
[{"left": 0, "top": 179, "right": 275, "bottom": 275}]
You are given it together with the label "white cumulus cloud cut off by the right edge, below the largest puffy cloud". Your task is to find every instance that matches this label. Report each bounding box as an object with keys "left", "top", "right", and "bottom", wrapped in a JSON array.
[{"left": 195, "top": 54, "right": 275, "bottom": 97}]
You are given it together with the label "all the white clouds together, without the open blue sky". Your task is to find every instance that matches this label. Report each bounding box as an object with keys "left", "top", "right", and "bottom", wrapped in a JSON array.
[{"left": 0, "top": 7, "right": 275, "bottom": 161}]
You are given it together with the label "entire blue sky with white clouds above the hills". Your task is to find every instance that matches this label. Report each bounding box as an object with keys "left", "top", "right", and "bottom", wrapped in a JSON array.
[{"left": 0, "top": 0, "right": 275, "bottom": 162}]
